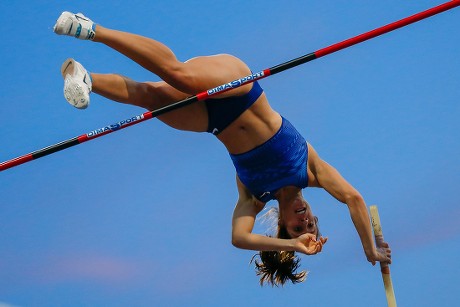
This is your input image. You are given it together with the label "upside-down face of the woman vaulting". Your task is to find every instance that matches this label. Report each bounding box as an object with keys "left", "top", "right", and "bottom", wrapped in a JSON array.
[{"left": 280, "top": 198, "right": 318, "bottom": 238}]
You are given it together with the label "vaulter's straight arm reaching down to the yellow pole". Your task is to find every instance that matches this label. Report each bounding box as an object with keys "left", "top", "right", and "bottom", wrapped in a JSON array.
[{"left": 308, "top": 144, "right": 391, "bottom": 264}]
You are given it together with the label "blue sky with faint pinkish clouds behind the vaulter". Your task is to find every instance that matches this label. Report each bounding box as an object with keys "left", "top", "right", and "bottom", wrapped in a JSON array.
[{"left": 0, "top": 0, "right": 460, "bottom": 306}]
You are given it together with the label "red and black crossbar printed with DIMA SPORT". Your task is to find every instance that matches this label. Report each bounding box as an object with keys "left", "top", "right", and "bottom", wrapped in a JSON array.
[{"left": 0, "top": 0, "right": 460, "bottom": 171}]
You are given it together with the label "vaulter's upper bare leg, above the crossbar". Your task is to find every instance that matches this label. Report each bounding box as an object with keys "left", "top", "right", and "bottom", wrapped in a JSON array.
[{"left": 94, "top": 25, "right": 250, "bottom": 95}]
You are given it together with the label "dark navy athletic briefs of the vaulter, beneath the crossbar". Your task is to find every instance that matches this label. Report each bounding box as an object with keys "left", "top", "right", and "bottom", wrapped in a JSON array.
[{"left": 205, "top": 81, "right": 263, "bottom": 135}]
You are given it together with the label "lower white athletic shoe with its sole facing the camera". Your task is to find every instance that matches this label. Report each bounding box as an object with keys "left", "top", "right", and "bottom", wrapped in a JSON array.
[{"left": 61, "top": 59, "right": 92, "bottom": 109}]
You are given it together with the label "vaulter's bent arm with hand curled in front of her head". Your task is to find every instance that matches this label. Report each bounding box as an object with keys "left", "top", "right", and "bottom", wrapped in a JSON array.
[{"left": 232, "top": 177, "right": 323, "bottom": 255}]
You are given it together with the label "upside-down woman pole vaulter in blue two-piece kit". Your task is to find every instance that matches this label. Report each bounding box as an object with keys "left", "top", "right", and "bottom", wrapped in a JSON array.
[{"left": 54, "top": 12, "right": 391, "bottom": 285}]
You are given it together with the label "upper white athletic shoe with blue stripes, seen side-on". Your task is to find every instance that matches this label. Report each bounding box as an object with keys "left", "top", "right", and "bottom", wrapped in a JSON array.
[{"left": 53, "top": 12, "right": 96, "bottom": 40}]
